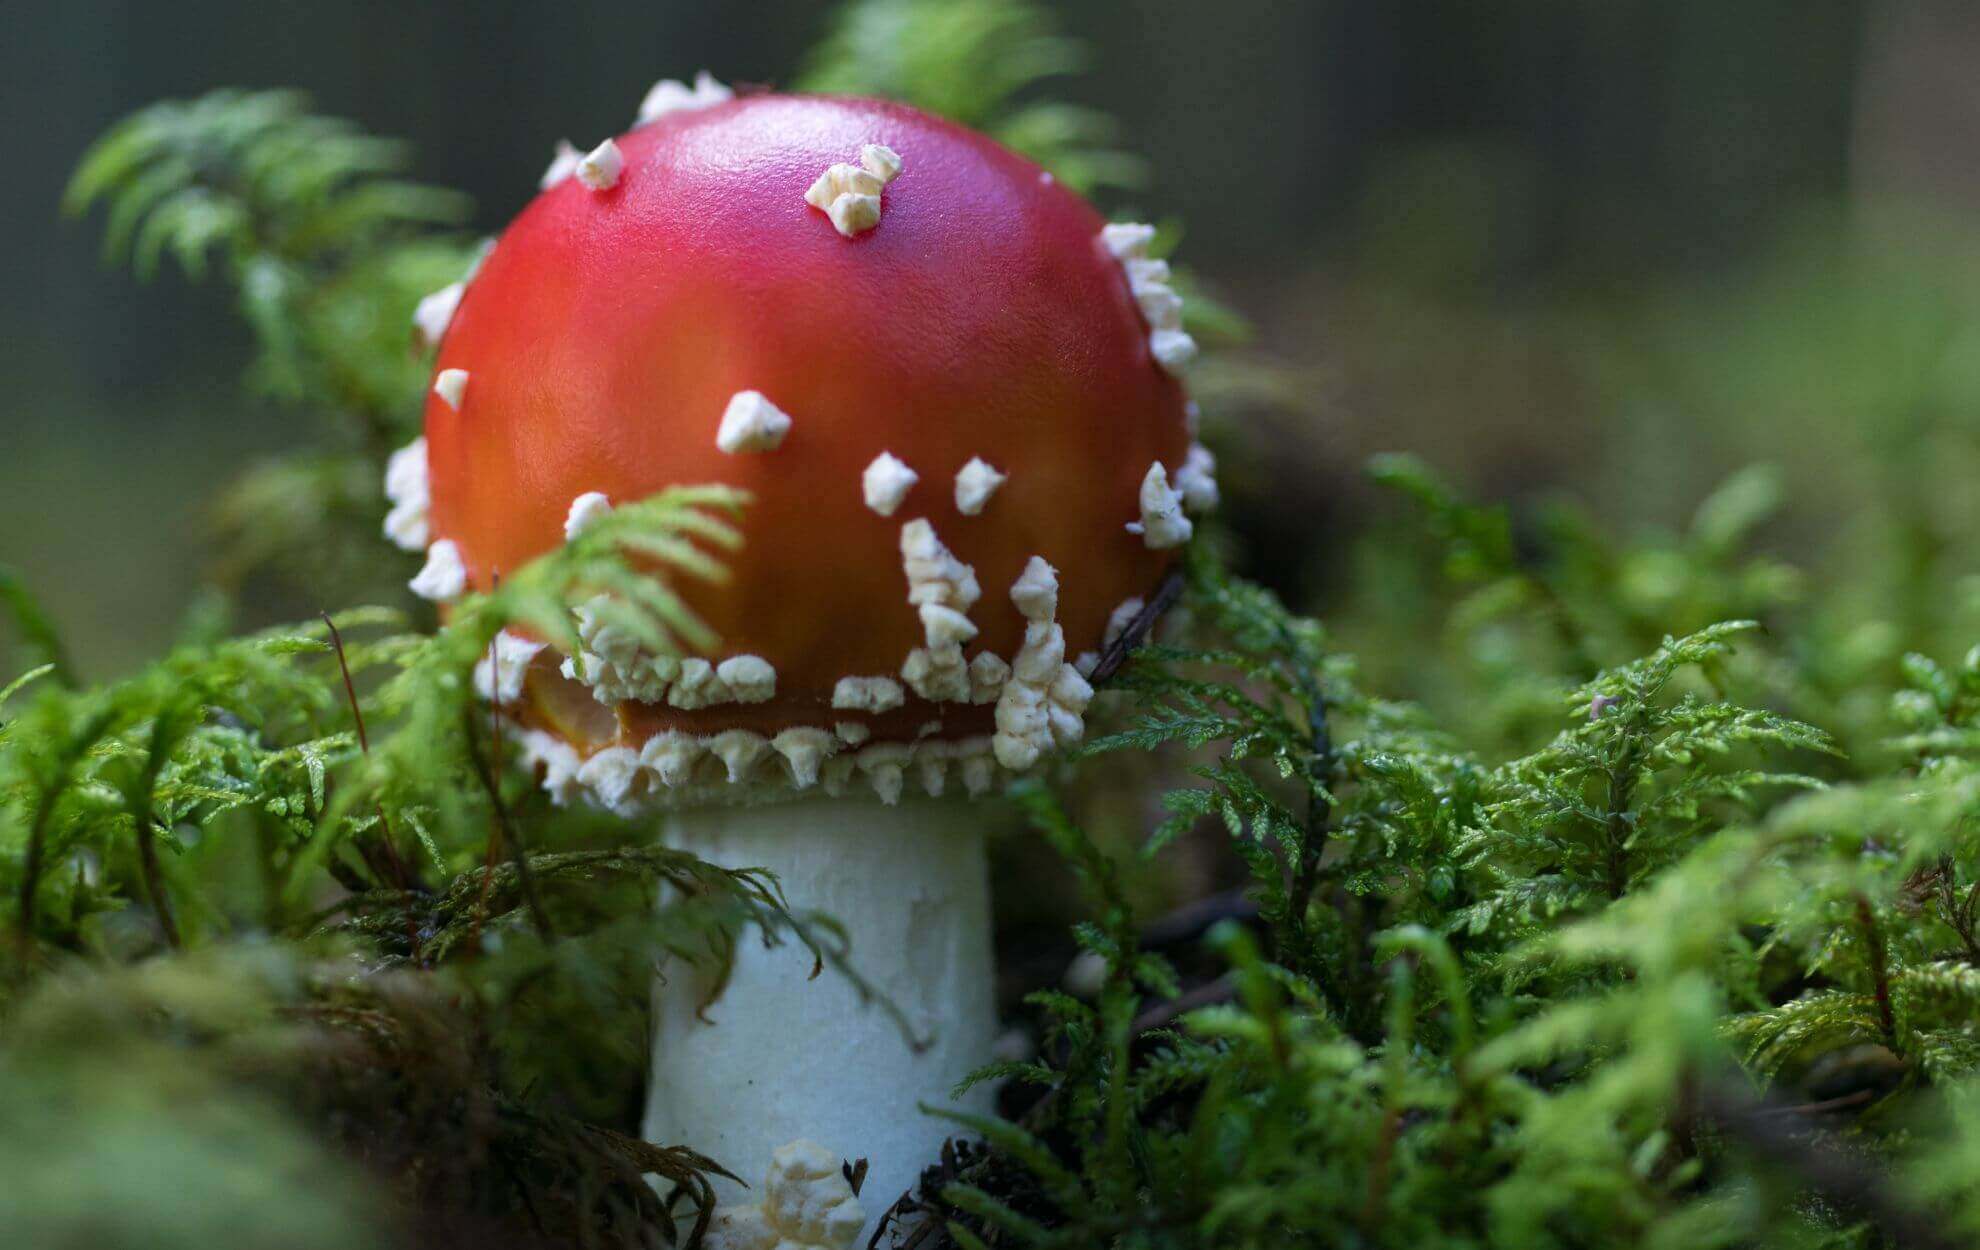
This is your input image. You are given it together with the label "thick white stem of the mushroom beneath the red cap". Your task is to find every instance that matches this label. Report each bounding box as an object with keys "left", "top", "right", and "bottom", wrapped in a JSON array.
[{"left": 645, "top": 798, "right": 1006, "bottom": 1244}]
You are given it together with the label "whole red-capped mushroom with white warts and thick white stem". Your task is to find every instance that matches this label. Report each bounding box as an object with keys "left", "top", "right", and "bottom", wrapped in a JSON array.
[{"left": 388, "top": 79, "right": 1214, "bottom": 1236}]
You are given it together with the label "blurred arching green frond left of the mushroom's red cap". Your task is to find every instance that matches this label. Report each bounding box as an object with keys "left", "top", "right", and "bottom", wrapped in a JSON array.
[{"left": 63, "top": 91, "right": 475, "bottom": 598}]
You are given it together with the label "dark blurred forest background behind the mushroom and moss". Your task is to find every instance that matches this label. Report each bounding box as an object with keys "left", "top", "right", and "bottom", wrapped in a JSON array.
[{"left": 0, "top": 0, "right": 1980, "bottom": 693}]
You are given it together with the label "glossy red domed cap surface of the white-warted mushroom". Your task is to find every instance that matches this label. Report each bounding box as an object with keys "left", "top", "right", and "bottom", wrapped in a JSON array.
[{"left": 426, "top": 95, "right": 1190, "bottom": 784}]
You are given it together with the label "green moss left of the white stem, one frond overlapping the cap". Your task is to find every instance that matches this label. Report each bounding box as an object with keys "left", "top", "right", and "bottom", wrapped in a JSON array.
[{"left": 0, "top": 481, "right": 799, "bottom": 1244}]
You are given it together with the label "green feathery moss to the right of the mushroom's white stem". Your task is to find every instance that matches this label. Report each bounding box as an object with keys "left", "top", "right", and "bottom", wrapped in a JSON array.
[{"left": 910, "top": 534, "right": 1980, "bottom": 1248}]
